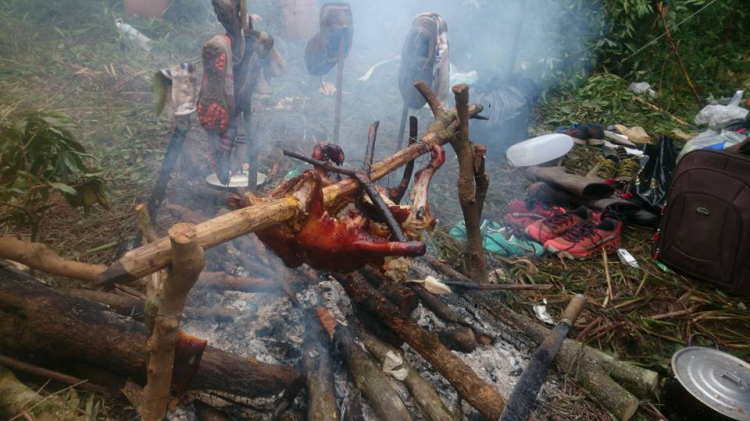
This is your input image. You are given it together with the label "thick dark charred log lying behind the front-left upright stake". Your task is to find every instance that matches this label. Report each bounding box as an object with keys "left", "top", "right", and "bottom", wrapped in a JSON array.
[{"left": 0, "top": 266, "right": 302, "bottom": 401}]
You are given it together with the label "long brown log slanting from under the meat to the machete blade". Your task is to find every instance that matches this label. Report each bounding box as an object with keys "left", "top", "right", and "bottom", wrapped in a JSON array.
[{"left": 336, "top": 273, "right": 505, "bottom": 419}]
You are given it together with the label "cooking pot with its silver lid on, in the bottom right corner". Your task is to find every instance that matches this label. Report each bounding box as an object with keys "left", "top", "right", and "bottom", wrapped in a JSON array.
[{"left": 661, "top": 335, "right": 750, "bottom": 421}]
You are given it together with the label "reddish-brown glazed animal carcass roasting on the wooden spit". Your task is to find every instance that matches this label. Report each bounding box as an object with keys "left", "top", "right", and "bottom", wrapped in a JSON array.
[{"left": 238, "top": 144, "right": 445, "bottom": 272}]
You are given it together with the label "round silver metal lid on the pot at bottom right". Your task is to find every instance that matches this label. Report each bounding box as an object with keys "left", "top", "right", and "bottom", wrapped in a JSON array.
[{"left": 672, "top": 346, "right": 750, "bottom": 421}]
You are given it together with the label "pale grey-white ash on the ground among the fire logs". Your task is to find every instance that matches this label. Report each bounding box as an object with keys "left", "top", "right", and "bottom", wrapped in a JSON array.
[{"left": 178, "top": 268, "right": 559, "bottom": 421}]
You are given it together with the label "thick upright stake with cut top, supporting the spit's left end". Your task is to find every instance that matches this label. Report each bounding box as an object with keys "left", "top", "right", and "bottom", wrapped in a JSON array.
[{"left": 143, "top": 223, "right": 206, "bottom": 421}]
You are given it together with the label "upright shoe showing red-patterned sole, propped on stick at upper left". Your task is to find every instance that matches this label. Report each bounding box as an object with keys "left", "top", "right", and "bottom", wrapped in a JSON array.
[{"left": 197, "top": 35, "right": 234, "bottom": 133}]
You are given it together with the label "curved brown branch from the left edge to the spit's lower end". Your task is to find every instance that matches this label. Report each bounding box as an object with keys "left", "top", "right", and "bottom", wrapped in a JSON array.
[{"left": 0, "top": 237, "right": 107, "bottom": 282}]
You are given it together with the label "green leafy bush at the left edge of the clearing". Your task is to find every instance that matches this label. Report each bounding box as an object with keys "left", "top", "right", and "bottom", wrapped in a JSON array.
[{"left": 0, "top": 112, "right": 108, "bottom": 241}]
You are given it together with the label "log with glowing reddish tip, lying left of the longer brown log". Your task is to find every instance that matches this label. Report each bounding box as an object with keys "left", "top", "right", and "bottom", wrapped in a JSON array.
[{"left": 317, "top": 308, "right": 411, "bottom": 421}]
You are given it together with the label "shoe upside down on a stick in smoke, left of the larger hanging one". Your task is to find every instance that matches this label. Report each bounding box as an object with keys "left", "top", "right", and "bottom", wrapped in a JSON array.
[{"left": 305, "top": 3, "right": 354, "bottom": 76}]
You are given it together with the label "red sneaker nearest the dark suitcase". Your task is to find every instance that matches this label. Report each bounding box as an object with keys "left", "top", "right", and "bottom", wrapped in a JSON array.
[{"left": 544, "top": 218, "right": 622, "bottom": 259}]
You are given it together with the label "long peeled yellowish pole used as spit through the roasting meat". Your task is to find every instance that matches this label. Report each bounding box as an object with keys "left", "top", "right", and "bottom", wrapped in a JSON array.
[{"left": 97, "top": 105, "right": 483, "bottom": 287}]
